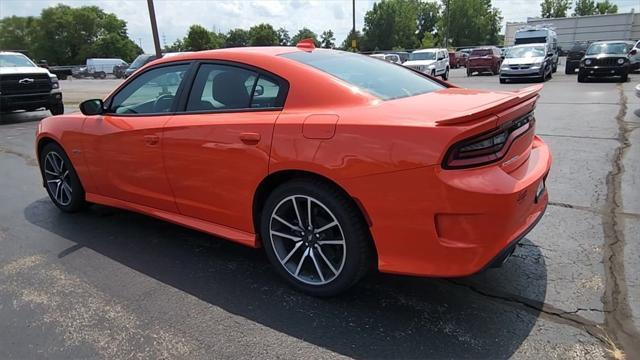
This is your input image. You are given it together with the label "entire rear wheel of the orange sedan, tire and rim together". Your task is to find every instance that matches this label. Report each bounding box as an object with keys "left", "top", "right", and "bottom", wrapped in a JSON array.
[{"left": 260, "top": 179, "right": 373, "bottom": 297}]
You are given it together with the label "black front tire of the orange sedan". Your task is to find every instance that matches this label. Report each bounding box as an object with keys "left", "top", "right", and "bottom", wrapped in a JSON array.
[{"left": 39, "top": 143, "right": 87, "bottom": 212}]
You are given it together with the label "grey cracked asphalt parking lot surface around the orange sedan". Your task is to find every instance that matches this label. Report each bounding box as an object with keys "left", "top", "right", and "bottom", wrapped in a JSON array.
[{"left": 0, "top": 68, "right": 640, "bottom": 359}]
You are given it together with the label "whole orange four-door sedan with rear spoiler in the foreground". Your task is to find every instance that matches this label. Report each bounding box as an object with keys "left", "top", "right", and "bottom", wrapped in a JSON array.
[{"left": 36, "top": 41, "right": 551, "bottom": 296}]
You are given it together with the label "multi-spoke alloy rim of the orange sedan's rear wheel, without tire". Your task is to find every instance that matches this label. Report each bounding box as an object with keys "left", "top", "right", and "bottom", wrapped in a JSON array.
[{"left": 269, "top": 195, "right": 347, "bottom": 285}]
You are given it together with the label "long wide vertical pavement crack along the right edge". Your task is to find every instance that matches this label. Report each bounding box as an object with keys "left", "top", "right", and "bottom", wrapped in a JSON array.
[{"left": 602, "top": 84, "right": 640, "bottom": 359}]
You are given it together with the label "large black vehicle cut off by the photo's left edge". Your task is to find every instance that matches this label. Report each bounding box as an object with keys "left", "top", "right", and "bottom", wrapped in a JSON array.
[{"left": 0, "top": 52, "right": 64, "bottom": 115}]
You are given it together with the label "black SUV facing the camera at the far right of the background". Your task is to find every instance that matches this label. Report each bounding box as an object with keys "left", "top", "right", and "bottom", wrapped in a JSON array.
[{"left": 578, "top": 41, "right": 635, "bottom": 82}]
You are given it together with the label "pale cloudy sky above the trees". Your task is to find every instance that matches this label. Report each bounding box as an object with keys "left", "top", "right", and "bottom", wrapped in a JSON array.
[{"left": 0, "top": 0, "right": 640, "bottom": 51}]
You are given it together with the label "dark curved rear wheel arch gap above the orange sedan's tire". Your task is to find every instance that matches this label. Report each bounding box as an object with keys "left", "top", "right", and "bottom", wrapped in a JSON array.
[{"left": 252, "top": 169, "right": 378, "bottom": 262}]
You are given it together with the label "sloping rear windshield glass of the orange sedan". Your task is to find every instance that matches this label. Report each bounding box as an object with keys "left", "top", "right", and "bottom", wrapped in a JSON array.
[{"left": 280, "top": 49, "right": 444, "bottom": 100}]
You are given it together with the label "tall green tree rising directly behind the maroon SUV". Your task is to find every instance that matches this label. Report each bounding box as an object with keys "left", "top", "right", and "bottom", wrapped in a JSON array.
[{"left": 437, "top": 0, "right": 502, "bottom": 47}]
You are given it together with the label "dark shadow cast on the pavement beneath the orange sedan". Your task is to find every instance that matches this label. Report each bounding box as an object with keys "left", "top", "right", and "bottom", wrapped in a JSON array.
[{"left": 24, "top": 199, "right": 547, "bottom": 359}]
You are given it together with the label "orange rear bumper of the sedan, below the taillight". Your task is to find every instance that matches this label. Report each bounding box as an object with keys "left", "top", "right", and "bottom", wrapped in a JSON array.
[{"left": 344, "top": 137, "right": 552, "bottom": 277}]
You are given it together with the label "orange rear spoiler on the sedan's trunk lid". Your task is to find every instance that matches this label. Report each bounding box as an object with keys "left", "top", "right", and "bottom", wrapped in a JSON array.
[{"left": 436, "top": 84, "right": 543, "bottom": 126}]
